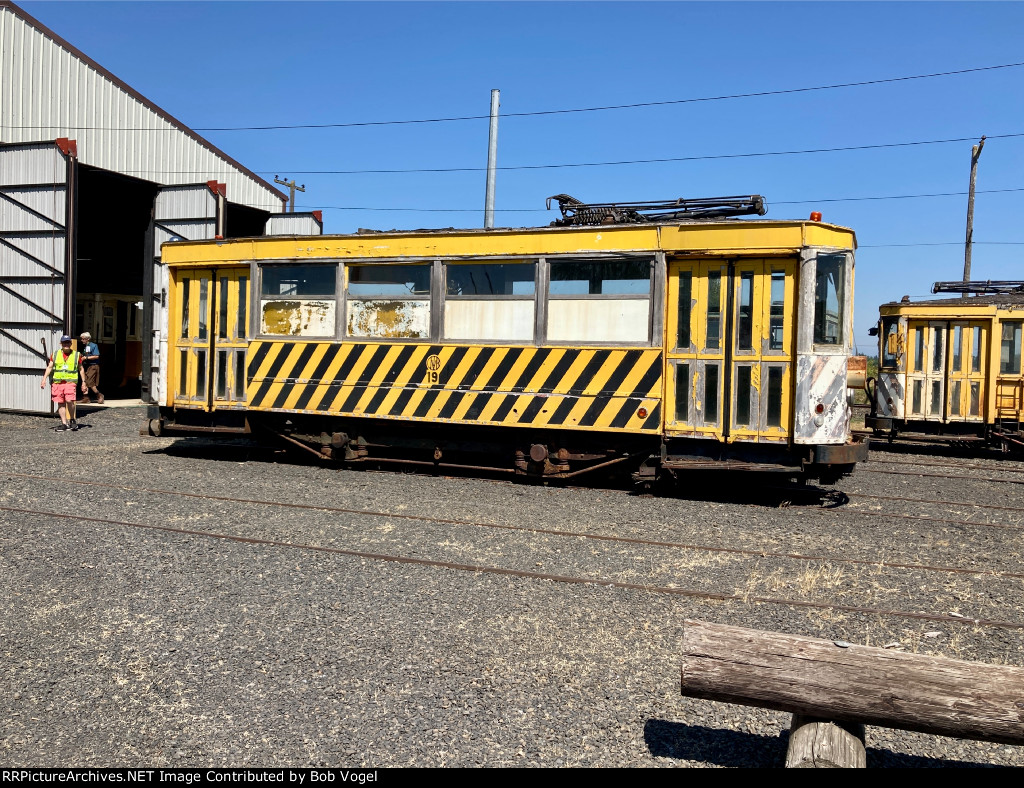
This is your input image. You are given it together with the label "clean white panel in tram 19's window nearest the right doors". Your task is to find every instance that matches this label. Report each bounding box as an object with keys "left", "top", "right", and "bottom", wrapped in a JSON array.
[{"left": 548, "top": 299, "right": 650, "bottom": 344}]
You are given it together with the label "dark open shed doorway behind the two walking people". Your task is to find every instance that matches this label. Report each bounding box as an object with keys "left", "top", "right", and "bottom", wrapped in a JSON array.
[{"left": 74, "top": 165, "right": 157, "bottom": 400}]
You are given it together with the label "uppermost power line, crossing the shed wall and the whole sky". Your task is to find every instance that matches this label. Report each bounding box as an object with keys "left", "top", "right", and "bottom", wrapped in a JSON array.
[{"left": 4, "top": 62, "right": 1024, "bottom": 132}]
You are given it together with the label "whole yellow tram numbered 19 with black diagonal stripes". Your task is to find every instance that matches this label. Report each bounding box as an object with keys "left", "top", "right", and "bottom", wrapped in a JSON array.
[{"left": 144, "top": 208, "right": 866, "bottom": 479}]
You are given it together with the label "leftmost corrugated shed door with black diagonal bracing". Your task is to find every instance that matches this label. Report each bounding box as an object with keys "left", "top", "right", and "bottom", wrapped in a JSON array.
[{"left": 0, "top": 142, "right": 69, "bottom": 412}]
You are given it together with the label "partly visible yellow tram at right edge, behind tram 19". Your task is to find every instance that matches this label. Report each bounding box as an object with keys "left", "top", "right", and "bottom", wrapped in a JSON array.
[{"left": 866, "top": 282, "right": 1024, "bottom": 447}]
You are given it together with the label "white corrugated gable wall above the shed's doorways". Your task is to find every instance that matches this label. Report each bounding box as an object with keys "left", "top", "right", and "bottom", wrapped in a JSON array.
[{"left": 0, "top": 6, "right": 282, "bottom": 212}]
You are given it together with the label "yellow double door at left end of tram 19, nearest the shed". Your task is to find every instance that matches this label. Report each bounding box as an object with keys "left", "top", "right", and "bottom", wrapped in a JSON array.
[{"left": 169, "top": 267, "right": 250, "bottom": 410}]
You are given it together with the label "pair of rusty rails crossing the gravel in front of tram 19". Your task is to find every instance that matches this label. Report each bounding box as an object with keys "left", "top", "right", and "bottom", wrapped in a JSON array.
[{"left": 0, "top": 473, "right": 1024, "bottom": 629}]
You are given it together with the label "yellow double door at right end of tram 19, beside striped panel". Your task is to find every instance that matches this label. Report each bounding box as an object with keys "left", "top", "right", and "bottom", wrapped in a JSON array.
[{"left": 666, "top": 259, "right": 796, "bottom": 442}]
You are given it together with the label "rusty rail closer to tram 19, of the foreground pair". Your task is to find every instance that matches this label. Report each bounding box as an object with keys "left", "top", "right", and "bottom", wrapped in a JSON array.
[{"left": 0, "top": 473, "right": 1024, "bottom": 579}]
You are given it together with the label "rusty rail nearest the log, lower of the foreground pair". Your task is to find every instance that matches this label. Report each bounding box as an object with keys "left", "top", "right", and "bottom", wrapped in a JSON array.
[{"left": 0, "top": 507, "right": 1024, "bottom": 629}]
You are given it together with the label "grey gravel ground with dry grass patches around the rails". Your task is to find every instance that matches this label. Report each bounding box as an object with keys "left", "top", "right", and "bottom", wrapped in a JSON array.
[{"left": 0, "top": 401, "right": 1024, "bottom": 767}]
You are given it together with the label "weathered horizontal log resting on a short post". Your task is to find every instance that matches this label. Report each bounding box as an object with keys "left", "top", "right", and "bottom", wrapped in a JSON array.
[{"left": 681, "top": 621, "right": 1024, "bottom": 744}]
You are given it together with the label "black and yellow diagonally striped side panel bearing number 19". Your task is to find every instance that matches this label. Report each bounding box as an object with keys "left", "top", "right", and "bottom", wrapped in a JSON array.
[{"left": 247, "top": 342, "right": 664, "bottom": 432}]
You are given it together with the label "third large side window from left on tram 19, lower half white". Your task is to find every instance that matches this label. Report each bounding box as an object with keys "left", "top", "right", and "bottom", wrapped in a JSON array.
[{"left": 444, "top": 263, "right": 537, "bottom": 342}]
